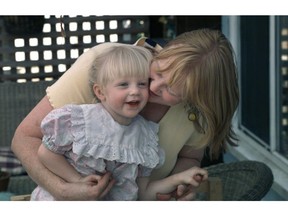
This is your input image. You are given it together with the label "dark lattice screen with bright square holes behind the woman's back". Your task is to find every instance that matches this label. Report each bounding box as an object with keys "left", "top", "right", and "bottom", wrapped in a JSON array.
[{"left": 0, "top": 16, "right": 149, "bottom": 82}]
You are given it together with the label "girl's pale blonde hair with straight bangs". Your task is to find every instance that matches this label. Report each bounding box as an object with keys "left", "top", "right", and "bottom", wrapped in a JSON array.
[{"left": 89, "top": 45, "right": 153, "bottom": 91}]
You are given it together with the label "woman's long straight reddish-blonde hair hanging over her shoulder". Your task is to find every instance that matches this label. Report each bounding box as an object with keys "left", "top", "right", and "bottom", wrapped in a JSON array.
[{"left": 154, "top": 29, "right": 239, "bottom": 158}]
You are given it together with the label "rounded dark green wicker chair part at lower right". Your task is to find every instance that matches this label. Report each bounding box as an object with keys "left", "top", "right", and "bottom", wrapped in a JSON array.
[{"left": 207, "top": 161, "right": 274, "bottom": 201}]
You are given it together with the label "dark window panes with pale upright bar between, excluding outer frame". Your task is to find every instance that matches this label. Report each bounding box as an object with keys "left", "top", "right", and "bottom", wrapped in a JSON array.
[{"left": 239, "top": 16, "right": 288, "bottom": 162}]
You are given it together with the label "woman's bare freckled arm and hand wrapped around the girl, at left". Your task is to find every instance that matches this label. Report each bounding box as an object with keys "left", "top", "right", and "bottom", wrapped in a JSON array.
[{"left": 11, "top": 96, "right": 114, "bottom": 200}]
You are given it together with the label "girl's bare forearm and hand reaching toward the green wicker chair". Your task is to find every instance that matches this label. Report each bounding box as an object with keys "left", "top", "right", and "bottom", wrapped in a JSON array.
[{"left": 137, "top": 167, "right": 208, "bottom": 200}]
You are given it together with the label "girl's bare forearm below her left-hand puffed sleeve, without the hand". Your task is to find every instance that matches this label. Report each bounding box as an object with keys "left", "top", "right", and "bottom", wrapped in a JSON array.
[{"left": 38, "top": 144, "right": 82, "bottom": 182}]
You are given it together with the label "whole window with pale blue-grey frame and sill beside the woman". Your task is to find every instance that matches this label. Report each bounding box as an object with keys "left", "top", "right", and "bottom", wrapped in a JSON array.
[{"left": 223, "top": 16, "right": 288, "bottom": 198}]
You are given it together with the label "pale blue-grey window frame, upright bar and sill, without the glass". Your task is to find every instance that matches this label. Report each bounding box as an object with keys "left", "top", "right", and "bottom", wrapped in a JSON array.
[{"left": 222, "top": 16, "right": 288, "bottom": 199}]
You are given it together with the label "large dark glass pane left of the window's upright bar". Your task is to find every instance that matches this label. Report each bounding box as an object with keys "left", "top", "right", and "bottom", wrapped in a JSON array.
[{"left": 240, "top": 16, "right": 270, "bottom": 148}]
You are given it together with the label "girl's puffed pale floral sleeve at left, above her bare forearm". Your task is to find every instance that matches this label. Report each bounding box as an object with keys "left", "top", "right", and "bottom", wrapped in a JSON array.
[{"left": 41, "top": 105, "right": 73, "bottom": 154}]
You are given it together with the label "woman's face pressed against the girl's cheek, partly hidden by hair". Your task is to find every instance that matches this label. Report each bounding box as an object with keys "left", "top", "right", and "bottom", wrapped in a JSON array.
[{"left": 149, "top": 60, "right": 182, "bottom": 106}]
